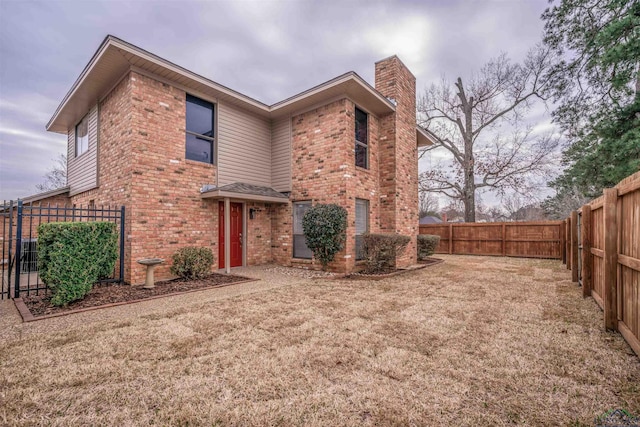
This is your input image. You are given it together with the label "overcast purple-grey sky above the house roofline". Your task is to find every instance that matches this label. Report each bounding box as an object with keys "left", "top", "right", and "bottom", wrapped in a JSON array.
[{"left": 0, "top": 0, "right": 548, "bottom": 200}]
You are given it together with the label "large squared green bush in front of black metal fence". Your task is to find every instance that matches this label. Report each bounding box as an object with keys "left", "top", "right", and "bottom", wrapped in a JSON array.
[{"left": 38, "top": 222, "right": 118, "bottom": 306}]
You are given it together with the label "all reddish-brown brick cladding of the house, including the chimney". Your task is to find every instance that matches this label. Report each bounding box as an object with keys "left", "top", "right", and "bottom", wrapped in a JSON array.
[{"left": 61, "top": 57, "right": 418, "bottom": 284}]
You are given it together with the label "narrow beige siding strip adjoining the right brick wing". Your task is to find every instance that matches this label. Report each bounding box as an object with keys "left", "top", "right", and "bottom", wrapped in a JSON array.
[{"left": 271, "top": 117, "right": 291, "bottom": 191}]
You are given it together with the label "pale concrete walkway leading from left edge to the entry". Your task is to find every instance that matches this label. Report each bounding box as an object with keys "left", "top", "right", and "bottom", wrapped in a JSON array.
[{"left": 0, "top": 265, "right": 310, "bottom": 340}]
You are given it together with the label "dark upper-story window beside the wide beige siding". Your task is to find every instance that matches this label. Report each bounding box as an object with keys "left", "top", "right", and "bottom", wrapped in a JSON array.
[{"left": 185, "top": 95, "right": 215, "bottom": 163}]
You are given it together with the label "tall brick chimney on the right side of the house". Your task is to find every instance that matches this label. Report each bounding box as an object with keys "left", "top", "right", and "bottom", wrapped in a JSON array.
[{"left": 375, "top": 55, "right": 419, "bottom": 267}]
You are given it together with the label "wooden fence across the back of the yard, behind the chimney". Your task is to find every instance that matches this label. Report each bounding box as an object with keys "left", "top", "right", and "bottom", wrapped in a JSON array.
[{"left": 420, "top": 221, "right": 565, "bottom": 259}]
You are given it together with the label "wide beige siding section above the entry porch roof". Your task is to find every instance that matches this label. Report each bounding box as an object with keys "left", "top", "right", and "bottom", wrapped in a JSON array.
[{"left": 217, "top": 103, "right": 271, "bottom": 187}]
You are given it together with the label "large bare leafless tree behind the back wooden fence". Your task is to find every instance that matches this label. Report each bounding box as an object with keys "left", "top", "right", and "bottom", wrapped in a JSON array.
[{"left": 418, "top": 46, "right": 558, "bottom": 222}]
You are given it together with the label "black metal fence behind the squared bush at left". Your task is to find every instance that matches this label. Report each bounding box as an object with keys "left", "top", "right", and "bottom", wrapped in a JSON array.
[{"left": 0, "top": 200, "right": 125, "bottom": 299}]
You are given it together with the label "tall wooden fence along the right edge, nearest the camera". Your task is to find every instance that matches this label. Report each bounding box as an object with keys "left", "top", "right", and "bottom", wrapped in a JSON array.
[{"left": 565, "top": 172, "right": 640, "bottom": 356}]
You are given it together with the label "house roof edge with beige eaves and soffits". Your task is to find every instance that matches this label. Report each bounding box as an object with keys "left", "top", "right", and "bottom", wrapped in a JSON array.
[{"left": 46, "top": 35, "right": 395, "bottom": 133}]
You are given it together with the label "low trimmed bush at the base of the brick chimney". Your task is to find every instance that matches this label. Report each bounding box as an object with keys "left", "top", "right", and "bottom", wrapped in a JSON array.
[{"left": 362, "top": 233, "right": 411, "bottom": 273}]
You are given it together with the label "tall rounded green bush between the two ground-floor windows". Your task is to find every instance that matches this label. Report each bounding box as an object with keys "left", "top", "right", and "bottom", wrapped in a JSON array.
[{"left": 302, "top": 204, "right": 347, "bottom": 268}]
